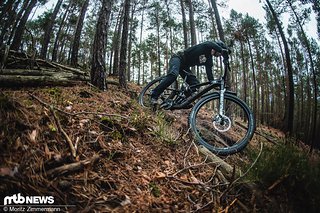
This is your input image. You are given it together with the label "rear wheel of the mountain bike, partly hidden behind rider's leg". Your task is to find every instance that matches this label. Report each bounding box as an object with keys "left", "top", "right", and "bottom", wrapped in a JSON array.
[{"left": 139, "top": 76, "right": 178, "bottom": 108}]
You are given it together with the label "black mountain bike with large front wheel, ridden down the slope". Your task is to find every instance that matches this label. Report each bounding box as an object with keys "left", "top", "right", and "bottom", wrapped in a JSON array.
[{"left": 139, "top": 53, "right": 255, "bottom": 155}]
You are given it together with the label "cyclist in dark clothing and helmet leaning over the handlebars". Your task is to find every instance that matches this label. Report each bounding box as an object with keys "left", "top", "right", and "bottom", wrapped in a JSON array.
[{"left": 151, "top": 41, "right": 228, "bottom": 106}]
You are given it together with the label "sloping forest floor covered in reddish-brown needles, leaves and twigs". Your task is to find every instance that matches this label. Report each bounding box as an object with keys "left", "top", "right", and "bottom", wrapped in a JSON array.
[{"left": 0, "top": 80, "right": 316, "bottom": 212}]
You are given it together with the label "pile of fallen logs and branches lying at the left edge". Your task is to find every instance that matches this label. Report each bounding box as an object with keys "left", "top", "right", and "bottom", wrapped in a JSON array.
[{"left": 0, "top": 49, "right": 90, "bottom": 87}]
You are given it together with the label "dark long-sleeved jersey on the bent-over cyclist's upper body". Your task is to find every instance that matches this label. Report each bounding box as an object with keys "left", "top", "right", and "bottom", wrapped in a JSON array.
[{"left": 183, "top": 41, "right": 222, "bottom": 81}]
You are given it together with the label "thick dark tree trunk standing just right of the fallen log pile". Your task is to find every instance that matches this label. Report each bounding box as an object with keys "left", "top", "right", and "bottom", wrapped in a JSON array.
[{"left": 91, "top": 0, "right": 113, "bottom": 90}]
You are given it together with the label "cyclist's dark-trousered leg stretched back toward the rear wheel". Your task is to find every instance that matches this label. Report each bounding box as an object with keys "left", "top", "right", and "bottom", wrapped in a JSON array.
[{"left": 151, "top": 57, "right": 181, "bottom": 100}]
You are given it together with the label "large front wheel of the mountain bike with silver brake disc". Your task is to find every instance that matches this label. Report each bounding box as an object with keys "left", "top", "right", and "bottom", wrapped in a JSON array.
[{"left": 189, "top": 93, "right": 255, "bottom": 155}]
